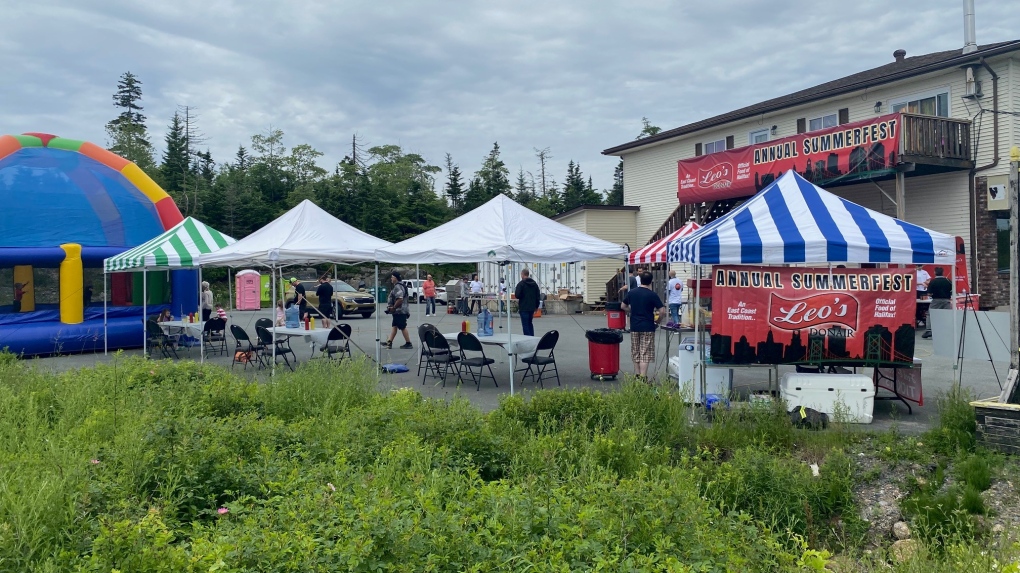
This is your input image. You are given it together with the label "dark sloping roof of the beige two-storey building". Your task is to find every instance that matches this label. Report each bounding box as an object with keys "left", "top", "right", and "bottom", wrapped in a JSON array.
[{"left": 602, "top": 40, "right": 1020, "bottom": 155}]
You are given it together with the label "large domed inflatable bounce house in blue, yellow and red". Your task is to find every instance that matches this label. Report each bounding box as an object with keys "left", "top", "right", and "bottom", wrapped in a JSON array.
[{"left": 0, "top": 134, "right": 198, "bottom": 356}]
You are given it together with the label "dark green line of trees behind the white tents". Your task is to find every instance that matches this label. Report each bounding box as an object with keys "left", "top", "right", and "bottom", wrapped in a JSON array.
[{"left": 106, "top": 71, "right": 628, "bottom": 242}]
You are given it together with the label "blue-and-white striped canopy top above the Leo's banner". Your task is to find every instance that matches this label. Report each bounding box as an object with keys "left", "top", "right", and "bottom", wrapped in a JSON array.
[{"left": 669, "top": 170, "right": 956, "bottom": 265}]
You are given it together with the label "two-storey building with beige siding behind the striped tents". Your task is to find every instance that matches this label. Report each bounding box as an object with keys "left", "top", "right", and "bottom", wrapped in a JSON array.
[{"left": 589, "top": 41, "right": 1020, "bottom": 307}]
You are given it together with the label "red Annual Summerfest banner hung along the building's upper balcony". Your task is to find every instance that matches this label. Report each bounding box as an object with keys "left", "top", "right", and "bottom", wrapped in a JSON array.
[{"left": 676, "top": 113, "right": 901, "bottom": 204}]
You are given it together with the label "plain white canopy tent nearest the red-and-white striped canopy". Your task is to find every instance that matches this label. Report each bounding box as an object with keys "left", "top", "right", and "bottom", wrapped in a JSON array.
[{"left": 375, "top": 195, "right": 628, "bottom": 395}]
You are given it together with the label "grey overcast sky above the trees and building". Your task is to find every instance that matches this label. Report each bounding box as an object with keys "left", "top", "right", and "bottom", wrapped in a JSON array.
[{"left": 0, "top": 0, "right": 1020, "bottom": 189}]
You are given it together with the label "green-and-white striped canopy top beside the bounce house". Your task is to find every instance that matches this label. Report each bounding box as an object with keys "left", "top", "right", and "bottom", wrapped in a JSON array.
[{"left": 103, "top": 217, "right": 235, "bottom": 272}]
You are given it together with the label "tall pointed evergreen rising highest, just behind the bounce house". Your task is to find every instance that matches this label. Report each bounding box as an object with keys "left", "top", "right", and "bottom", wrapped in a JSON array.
[{"left": 106, "top": 71, "right": 157, "bottom": 174}]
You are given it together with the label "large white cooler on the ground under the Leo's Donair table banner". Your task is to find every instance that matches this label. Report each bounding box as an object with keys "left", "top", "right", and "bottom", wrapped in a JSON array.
[{"left": 779, "top": 372, "right": 875, "bottom": 424}]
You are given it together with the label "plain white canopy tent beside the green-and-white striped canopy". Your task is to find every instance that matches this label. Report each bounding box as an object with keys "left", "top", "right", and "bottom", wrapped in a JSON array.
[{"left": 200, "top": 199, "right": 393, "bottom": 365}]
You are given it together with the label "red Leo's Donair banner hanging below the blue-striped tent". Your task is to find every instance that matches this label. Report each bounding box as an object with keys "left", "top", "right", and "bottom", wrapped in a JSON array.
[{"left": 712, "top": 266, "right": 916, "bottom": 364}]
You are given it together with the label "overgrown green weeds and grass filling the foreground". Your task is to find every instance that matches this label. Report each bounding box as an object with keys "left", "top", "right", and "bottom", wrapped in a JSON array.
[{"left": 0, "top": 353, "right": 1017, "bottom": 572}]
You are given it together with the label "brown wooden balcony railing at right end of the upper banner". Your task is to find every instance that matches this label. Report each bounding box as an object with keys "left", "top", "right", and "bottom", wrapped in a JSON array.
[{"left": 900, "top": 113, "right": 974, "bottom": 169}]
